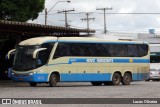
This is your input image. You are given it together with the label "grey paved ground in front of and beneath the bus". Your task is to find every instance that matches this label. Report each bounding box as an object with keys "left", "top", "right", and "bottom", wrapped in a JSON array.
[{"left": 0, "top": 81, "right": 160, "bottom": 107}]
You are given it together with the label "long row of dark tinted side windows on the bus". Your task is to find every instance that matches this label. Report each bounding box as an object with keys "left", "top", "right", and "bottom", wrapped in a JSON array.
[{"left": 54, "top": 43, "right": 148, "bottom": 58}]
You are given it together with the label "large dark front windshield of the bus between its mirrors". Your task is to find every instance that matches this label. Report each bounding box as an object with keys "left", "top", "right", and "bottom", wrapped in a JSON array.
[{"left": 13, "top": 46, "right": 39, "bottom": 71}]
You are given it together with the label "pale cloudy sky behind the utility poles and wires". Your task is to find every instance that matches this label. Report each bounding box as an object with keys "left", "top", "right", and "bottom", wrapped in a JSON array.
[{"left": 29, "top": 0, "right": 160, "bottom": 34}]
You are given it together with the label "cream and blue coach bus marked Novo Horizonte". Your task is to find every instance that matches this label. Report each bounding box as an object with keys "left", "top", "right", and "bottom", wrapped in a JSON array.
[{"left": 8, "top": 37, "right": 150, "bottom": 87}]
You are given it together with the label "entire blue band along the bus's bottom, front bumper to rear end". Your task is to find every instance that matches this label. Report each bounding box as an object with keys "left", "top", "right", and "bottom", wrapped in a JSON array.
[{"left": 12, "top": 73, "right": 147, "bottom": 82}]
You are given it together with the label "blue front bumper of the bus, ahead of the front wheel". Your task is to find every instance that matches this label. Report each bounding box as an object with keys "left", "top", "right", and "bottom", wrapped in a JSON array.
[{"left": 12, "top": 73, "right": 48, "bottom": 83}]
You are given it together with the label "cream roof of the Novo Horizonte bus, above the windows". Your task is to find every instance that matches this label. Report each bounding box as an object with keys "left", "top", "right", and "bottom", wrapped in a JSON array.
[{"left": 19, "top": 37, "right": 147, "bottom": 45}]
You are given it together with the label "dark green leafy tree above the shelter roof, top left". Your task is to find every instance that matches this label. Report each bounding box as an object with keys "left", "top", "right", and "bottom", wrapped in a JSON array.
[{"left": 0, "top": 0, "right": 45, "bottom": 22}]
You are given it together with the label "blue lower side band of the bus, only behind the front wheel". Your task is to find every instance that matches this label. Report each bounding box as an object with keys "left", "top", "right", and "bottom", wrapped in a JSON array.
[{"left": 60, "top": 73, "right": 147, "bottom": 82}]
